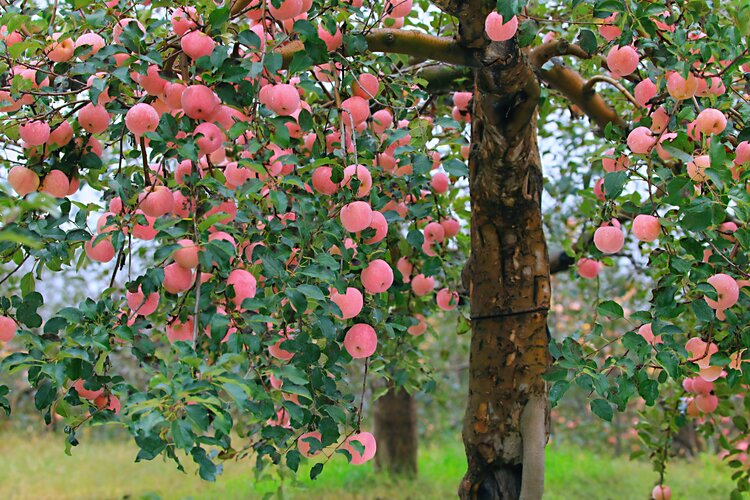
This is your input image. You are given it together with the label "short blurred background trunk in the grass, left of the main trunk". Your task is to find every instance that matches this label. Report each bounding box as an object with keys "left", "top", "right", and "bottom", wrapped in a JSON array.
[{"left": 375, "top": 387, "right": 417, "bottom": 477}]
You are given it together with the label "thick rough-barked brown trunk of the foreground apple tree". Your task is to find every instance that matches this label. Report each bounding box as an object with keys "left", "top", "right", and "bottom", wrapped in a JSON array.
[{"left": 459, "top": 42, "right": 550, "bottom": 500}]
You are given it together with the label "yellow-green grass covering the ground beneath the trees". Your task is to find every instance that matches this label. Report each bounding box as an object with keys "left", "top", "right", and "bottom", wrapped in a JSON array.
[{"left": 0, "top": 433, "right": 732, "bottom": 500}]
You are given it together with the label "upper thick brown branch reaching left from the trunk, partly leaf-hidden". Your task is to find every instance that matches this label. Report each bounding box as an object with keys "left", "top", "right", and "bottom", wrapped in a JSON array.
[{"left": 277, "top": 28, "right": 479, "bottom": 67}]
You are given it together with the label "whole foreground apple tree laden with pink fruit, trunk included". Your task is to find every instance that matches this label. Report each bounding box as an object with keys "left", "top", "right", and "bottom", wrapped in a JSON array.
[{"left": 0, "top": 0, "right": 750, "bottom": 498}]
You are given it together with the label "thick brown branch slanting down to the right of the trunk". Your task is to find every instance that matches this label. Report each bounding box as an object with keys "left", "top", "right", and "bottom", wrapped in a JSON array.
[{"left": 540, "top": 64, "right": 625, "bottom": 129}]
